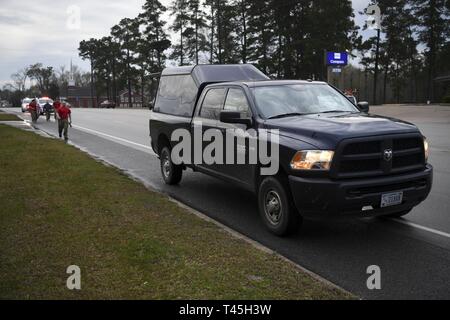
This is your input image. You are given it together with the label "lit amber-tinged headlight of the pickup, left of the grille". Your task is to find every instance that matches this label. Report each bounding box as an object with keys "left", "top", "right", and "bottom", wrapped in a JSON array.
[{"left": 291, "top": 150, "right": 334, "bottom": 170}]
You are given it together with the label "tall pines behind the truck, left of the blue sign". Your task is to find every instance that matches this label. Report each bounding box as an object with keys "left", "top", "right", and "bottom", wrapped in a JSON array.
[{"left": 79, "top": 0, "right": 360, "bottom": 106}]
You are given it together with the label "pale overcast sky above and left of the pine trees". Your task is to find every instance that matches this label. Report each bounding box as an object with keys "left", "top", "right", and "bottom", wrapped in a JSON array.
[{"left": 0, "top": 0, "right": 369, "bottom": 87}]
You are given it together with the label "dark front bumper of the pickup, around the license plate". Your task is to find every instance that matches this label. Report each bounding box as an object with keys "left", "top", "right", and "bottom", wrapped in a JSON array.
[{"left": 289, "top": 165, "right": 433, "bottom": 218}]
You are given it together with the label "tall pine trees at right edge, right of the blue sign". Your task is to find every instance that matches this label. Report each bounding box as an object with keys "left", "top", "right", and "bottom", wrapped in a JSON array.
[{"left": 357, "top": 0, "right": 450, "bottom": 103}]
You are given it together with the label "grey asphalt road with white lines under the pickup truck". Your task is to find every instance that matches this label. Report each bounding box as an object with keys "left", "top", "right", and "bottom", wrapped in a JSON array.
[{"left": 1, "top": 106, "right": 450, "bottom": 299}]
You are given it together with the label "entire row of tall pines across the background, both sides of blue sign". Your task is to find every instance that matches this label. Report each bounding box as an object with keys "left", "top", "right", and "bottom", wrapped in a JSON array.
[{"left": 1, "top": 0, "right": 450, "bottom": 107}]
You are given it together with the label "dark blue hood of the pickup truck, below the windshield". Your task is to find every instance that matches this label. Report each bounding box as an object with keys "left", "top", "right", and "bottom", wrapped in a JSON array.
[{"left": 265, "top": 113, "right": 419, "bottom": 150}]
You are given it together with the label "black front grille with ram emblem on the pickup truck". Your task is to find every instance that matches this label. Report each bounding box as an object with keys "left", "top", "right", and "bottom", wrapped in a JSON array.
[{"left": 332, "top": 134, "right": 425, "bottom": 178}]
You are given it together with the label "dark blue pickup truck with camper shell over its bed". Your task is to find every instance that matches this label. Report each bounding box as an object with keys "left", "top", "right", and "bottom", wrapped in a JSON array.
[{"left": 150, "top": 65, "right": 433, "bottom": 236}]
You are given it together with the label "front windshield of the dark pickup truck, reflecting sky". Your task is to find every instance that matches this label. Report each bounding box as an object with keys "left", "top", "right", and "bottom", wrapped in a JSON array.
[{"left": 252, "top": 84, "right": 360, "bottom": 119}]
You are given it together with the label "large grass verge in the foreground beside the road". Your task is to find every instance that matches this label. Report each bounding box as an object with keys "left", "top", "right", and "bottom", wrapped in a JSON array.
[{"left": 0, "top": 125, "right": 351, "bottom": 299}]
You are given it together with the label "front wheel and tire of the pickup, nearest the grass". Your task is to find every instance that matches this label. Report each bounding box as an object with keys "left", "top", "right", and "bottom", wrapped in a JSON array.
[{"left": 258, "top": 177, "right": 303, "bottom": 237}]
